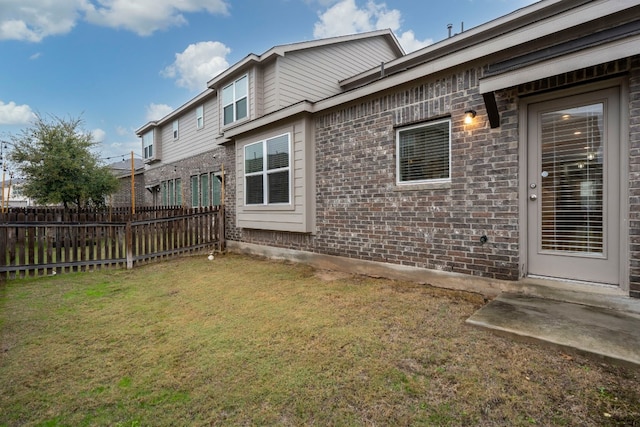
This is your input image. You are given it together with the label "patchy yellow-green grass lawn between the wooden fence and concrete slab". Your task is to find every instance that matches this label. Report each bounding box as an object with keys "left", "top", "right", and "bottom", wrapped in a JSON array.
[{"left": 0, "top": 255, "right": 640, "bottom": 426}]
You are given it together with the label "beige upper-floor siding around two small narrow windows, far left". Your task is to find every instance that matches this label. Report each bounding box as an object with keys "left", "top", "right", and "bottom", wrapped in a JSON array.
[{"left": 162, "top": 96, "right": 219, "bottom": 163}]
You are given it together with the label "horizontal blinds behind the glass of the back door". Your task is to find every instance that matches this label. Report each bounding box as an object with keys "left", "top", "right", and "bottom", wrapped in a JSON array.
[{"left": 540, "top": 103, "right": 604, "bottom": 253}]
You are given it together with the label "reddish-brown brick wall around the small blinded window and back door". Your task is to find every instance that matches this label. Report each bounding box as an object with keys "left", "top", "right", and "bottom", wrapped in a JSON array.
[{"left": 228, "top": 58, "right": 640, "bottom": 296}]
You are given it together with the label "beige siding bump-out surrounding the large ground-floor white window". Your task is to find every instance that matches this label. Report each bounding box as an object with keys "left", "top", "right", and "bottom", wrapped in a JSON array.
[{"left": 236, "top": 119, "right": 315, "bottom": 233}]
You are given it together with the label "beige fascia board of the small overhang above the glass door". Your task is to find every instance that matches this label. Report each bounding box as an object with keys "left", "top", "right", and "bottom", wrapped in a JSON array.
[{"left": 480, "top": 35, "right": 640, "bottom": 93}]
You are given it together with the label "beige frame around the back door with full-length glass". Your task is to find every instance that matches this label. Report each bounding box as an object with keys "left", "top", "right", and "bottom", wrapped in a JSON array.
[{"left": 518, "top": 77, "right": 630, "bottom": 292}]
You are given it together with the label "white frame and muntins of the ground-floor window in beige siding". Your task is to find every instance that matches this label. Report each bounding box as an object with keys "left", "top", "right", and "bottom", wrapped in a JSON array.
[{"left": 242, "top": 132, "right": 293, "bottom": 208}]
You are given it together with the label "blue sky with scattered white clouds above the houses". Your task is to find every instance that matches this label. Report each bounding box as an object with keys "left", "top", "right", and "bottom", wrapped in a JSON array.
[{"left": 0, "top": 0, "right": 535, "bottom": 163}]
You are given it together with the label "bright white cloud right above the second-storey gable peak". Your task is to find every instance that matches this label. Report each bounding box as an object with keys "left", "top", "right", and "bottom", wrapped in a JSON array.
[{"left": 313, "top": 0, "right": 432, "bottom": 52}]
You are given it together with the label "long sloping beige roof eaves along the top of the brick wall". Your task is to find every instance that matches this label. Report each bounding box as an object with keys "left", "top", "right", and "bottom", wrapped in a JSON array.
[{"left": 219, "top": 0, "right": 640, "bottom": 138}]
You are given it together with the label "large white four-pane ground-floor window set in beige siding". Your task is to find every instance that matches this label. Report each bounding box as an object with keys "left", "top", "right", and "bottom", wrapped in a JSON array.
[{"left": 244, "top": 133, "right": 291, "bottom": 205}]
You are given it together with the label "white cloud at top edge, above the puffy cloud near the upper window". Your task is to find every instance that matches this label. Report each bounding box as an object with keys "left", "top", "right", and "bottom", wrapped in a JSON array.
[{"left": 86, "top": 0, "right": 228, "bottom": 36}]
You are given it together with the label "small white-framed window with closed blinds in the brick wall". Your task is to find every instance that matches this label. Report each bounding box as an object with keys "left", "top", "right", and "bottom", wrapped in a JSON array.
[{"left": 396, "top": 119, "right": 451, "bottom": 184}]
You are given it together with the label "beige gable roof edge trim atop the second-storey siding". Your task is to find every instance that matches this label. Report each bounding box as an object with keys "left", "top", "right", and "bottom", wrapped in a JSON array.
[{"left": 207, "top": 29, "right": 405, "bottom": 89}]
